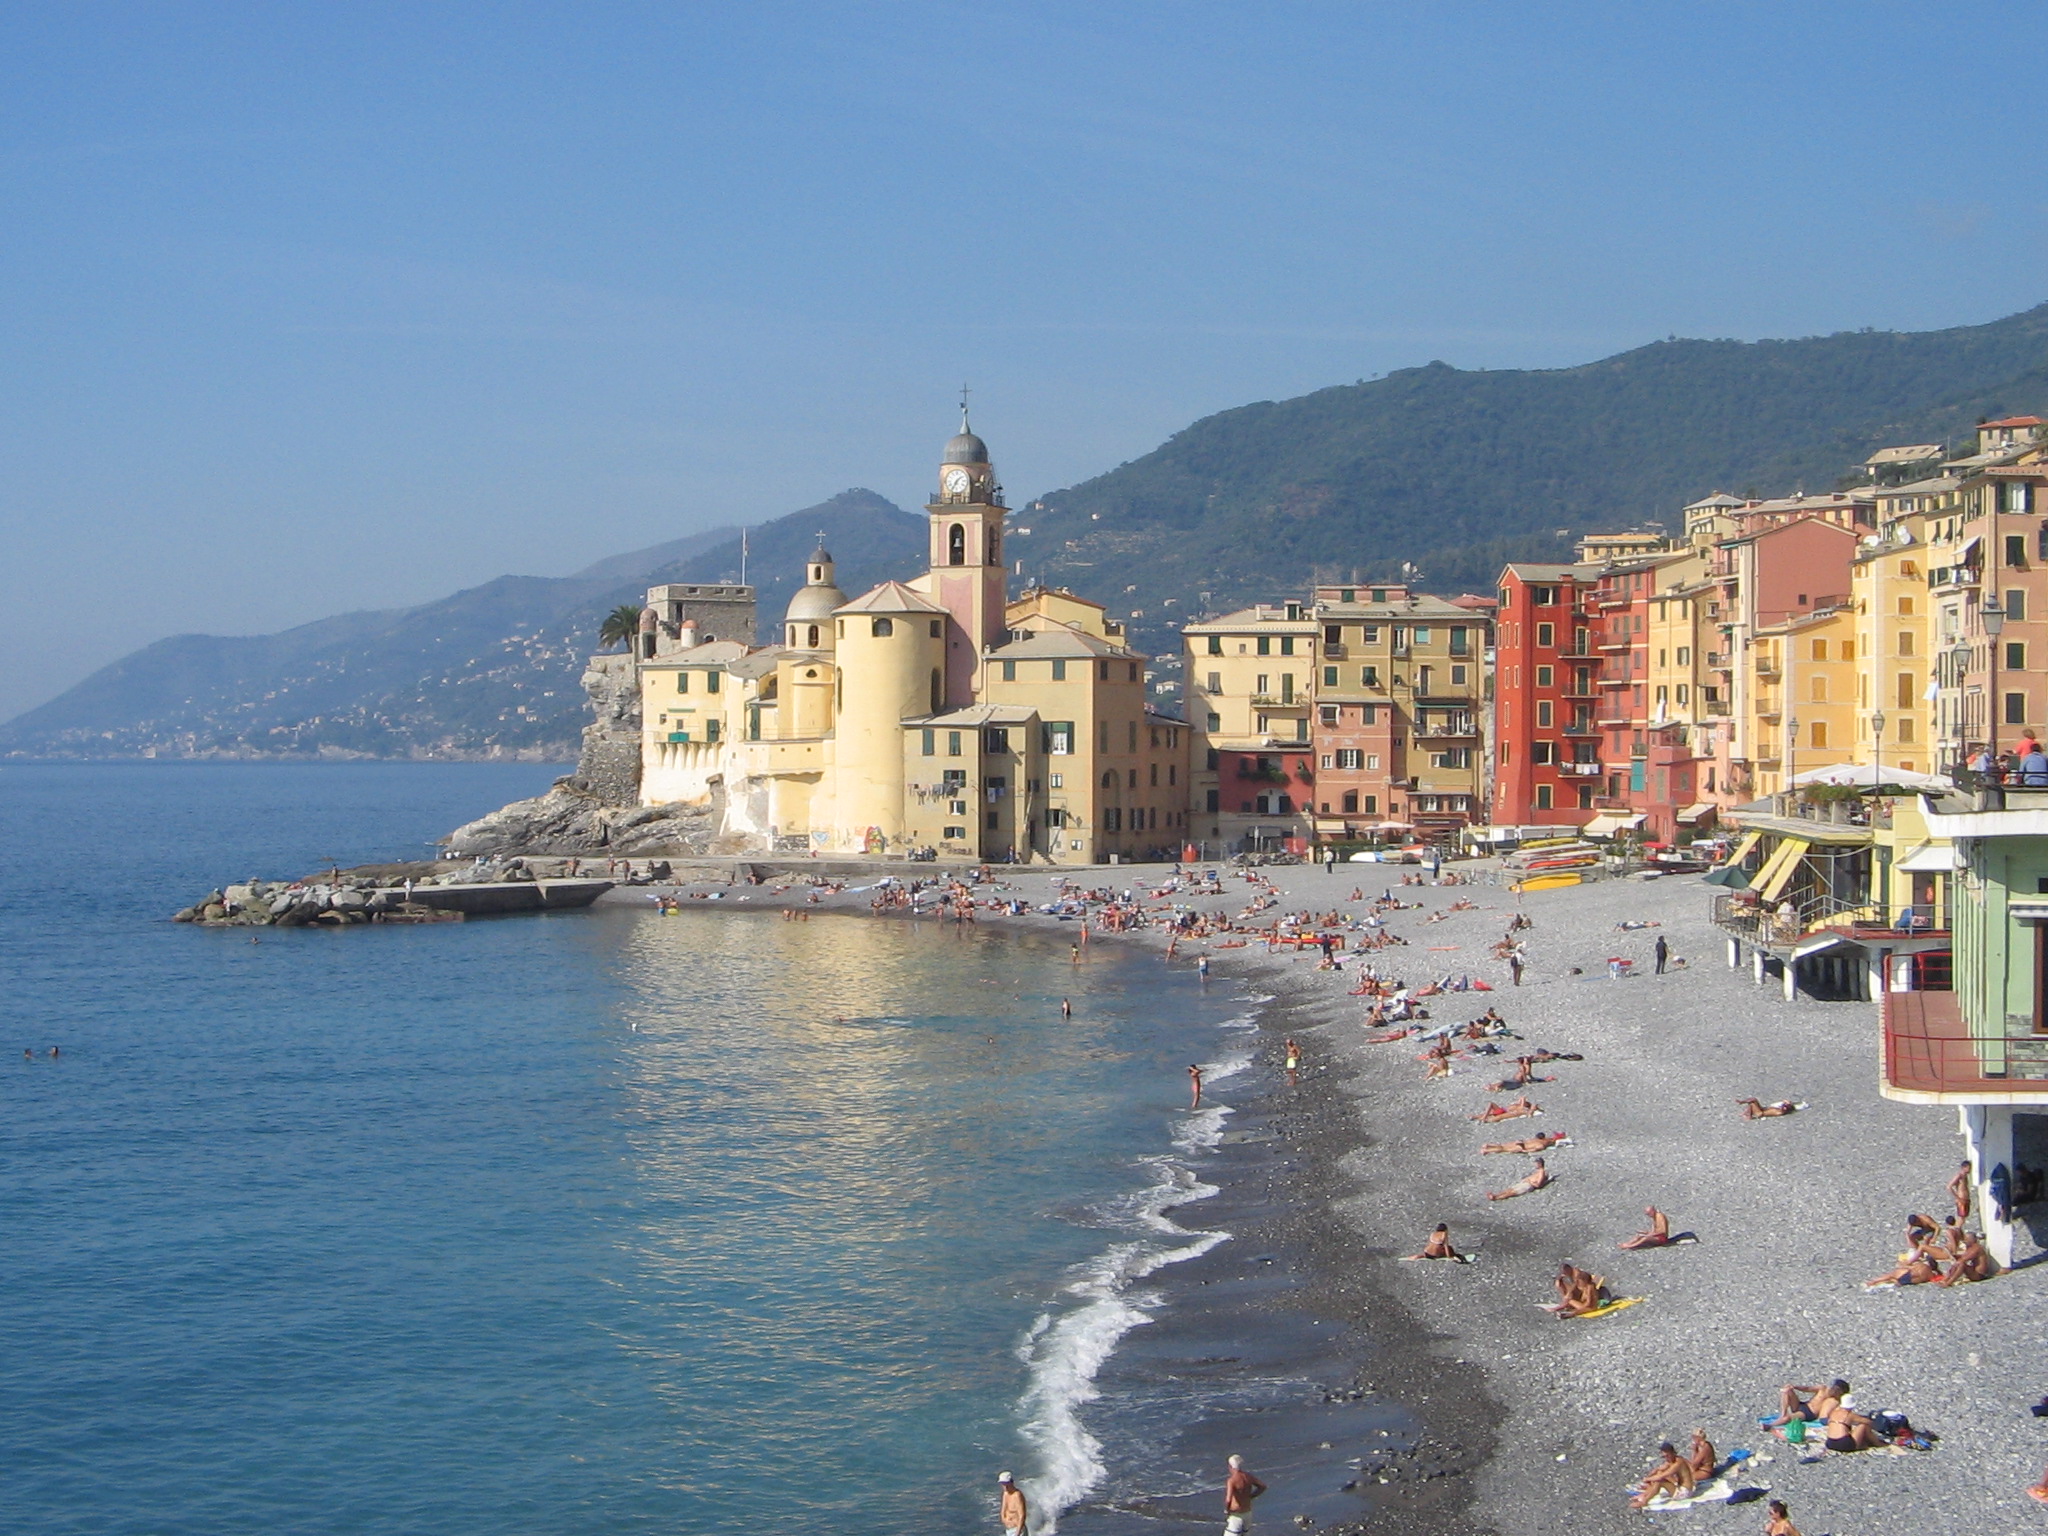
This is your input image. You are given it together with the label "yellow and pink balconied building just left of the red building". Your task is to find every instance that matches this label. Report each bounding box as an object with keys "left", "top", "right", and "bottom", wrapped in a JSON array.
[{"left": 1311, "top": 584, "right": 1491, "bottom": 842}]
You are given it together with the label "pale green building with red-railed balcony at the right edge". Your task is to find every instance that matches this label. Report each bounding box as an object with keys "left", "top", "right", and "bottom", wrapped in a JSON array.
[{"left": 1880, "top": 786, "right": 2048, "bottom": 1264}]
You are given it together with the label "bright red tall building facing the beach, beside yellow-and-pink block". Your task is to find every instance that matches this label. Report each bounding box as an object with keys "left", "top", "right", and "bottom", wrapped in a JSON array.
[{"left": 1493, "top": 563, "right": 1604, "bottom": 827}]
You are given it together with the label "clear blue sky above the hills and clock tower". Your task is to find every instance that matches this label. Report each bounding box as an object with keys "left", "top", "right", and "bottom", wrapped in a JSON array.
[{"left": 0, "top": 0, "right": 2048, "bottom": 719}]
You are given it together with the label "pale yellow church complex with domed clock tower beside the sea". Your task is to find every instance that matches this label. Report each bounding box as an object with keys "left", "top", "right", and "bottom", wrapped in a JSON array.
[{"left": 635, "top": 421, "right": 1190, "bottom": 864}]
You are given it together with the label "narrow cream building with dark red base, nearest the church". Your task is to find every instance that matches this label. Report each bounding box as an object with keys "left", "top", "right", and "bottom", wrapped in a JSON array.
[{"left": 1182, "top": 602, "right": 1321, "bottom": 852}]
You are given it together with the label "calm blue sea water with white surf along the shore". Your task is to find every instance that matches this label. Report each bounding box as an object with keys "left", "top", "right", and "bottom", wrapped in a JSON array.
[{"left": 0, "top": 764, "right": 1249, "bottom": 1536}]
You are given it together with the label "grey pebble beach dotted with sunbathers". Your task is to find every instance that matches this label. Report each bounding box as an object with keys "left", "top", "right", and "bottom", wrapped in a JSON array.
[{"left": 621, "top": 864, "right": 2048, "bottom": 1536}]
